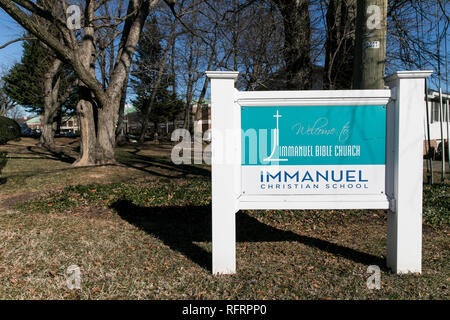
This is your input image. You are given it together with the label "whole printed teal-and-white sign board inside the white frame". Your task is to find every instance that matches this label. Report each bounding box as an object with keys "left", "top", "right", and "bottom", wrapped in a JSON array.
[{"left": 241, "top": 105, "right": 386, "bottom": 195}]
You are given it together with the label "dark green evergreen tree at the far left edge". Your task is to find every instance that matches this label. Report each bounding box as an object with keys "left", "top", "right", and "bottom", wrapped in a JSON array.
[{"left": 2, "top": 40, "right": 78, "bottom": 149}]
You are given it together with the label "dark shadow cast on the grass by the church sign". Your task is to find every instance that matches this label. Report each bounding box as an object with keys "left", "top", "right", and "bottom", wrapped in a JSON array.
[{"left": 111, "top": 200, "right": 386, "bottom": 271}]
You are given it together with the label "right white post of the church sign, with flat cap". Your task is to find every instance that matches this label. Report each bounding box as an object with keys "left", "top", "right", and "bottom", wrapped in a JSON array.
[{"left": 386, "top": 71, "right": 431, "bottom": 273}]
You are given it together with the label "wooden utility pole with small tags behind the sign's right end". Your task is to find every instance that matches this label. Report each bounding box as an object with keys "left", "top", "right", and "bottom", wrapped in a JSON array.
[{"left": 353, "top": 0, "right": 387, "bottom": 89}]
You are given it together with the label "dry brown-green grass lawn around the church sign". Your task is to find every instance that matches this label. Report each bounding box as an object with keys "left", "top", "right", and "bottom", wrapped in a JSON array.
[{"left": 0, "top": 139, "right": 450, "bottom": 299}]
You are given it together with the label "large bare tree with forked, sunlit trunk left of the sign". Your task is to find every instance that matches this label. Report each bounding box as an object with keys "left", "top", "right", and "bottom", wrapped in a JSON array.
[{"left": 0, "top": 0, "right": 165, "bottom": 166}]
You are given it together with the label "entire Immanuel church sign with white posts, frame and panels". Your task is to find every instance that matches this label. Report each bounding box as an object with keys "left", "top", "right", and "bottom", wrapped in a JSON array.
[{"left": 207, "top": 71, "right": 431, "bottom": 274}]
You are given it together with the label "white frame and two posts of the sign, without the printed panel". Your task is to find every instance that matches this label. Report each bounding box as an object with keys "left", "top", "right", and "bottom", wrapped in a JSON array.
[{"left": 206, "top": 71, "right": 432, "bottom": 274}]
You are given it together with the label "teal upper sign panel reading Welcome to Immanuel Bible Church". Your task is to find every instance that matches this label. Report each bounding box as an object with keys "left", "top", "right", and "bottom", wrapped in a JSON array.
[{"left": 241, "top": 106, "right": 386, "bottom": 165}]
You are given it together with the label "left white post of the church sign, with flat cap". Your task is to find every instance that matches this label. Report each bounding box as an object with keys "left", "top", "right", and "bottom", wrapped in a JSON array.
[{"left": 206, "top": 71, "right": 240, "bottom": 274}]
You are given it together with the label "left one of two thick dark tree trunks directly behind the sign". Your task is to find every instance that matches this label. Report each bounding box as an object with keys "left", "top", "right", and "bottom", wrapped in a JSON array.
[{"left": 274, "top": 0, "right": 312, "bottom": 90}]
